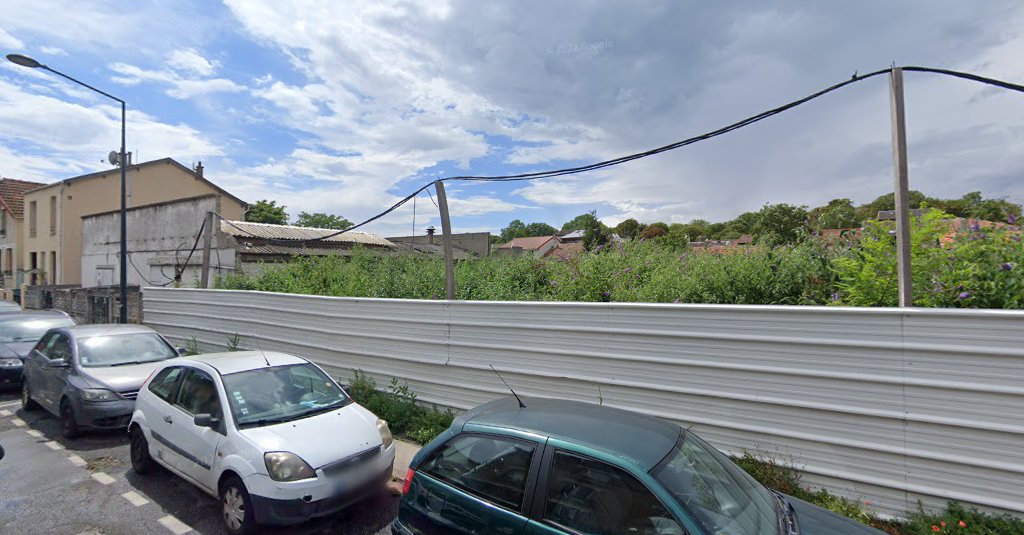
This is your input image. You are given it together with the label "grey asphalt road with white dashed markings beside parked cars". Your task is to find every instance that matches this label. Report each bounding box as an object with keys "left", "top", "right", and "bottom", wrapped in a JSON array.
[{"left": 0, "top": 392, "right": 398, "bottom": 535}]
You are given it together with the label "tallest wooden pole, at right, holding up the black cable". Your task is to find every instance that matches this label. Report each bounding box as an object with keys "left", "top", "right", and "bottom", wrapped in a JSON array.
[{"left": 889, "top": 67, "right": 913, "bottom": 306}]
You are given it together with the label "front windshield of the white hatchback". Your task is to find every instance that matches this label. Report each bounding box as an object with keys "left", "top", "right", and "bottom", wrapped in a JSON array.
[{"left": 224, "top": 363, "right": 350, "bottom": 426}]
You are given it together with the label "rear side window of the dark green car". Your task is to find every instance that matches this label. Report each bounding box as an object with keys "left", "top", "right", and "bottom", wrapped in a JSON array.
[{"left": 422, "top": 435, "right": 536, "bottom": 511}]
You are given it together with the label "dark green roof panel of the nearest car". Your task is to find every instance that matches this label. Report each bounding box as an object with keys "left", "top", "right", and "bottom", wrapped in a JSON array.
[{"left": 459, "top": 397, "right": 682, "bottom": 470}]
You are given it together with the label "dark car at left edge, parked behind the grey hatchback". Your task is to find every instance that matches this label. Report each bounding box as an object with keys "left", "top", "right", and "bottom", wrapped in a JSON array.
[{"left": 0, "top": 301, "right": 75, "bottom": 387}]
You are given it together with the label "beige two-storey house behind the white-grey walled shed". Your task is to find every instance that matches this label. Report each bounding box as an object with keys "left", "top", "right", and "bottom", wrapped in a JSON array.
[{"left": 20, "top": 158, "right": 247, "bottom": 284}]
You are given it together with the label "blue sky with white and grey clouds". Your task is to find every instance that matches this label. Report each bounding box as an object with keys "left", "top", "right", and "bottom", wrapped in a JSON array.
[{"left": 0, "top": 0, "right": 1024, "bottom": 234}]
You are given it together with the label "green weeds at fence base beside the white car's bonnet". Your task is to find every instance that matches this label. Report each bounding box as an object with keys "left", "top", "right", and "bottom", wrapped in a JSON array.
[{"left": 348, "top": 370, "right": 455, "bottom": 444}]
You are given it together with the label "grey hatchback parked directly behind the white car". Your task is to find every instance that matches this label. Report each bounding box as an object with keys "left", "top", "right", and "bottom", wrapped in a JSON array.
[{"left": 22, "top": 324, "right": 179, "bottom": 439}]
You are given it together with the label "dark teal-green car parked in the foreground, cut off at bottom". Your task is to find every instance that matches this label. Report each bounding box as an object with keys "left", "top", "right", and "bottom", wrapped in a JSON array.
[{"left": 391, "top": 398, "right": 882, "bottom": 535}]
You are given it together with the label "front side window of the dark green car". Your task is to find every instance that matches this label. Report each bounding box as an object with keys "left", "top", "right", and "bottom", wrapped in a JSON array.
[{"left": 544, "top": 452, "right": 685, "bottom": 535}]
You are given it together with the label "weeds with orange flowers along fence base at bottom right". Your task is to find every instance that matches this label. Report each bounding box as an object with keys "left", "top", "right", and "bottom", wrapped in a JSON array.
[{"left": 732, "top": 452, "right": 1024, "bottom": 535}]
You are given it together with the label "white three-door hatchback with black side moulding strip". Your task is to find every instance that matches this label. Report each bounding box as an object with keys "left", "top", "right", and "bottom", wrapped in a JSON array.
[{"left": 128, "top": 352, "right": 394, "bottom": 534}]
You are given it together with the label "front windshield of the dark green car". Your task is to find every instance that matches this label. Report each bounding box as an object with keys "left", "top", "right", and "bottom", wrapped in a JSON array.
[{"left": 651, "top": 433, "right": 779, "bottom": 535}]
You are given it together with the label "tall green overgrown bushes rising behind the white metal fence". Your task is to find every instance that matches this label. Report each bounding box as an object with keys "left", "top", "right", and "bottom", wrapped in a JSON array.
[{"left": 217, "top": 210, "right": 1024, "bottom": 308}]
